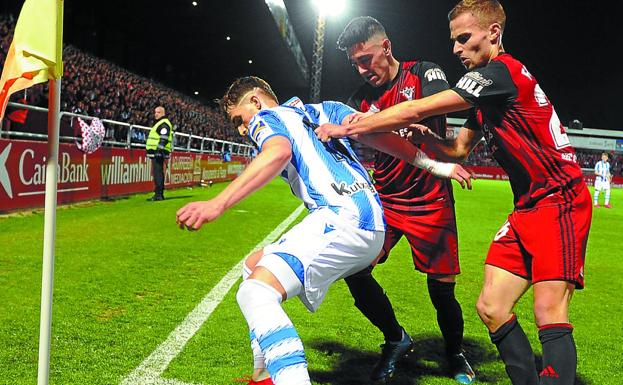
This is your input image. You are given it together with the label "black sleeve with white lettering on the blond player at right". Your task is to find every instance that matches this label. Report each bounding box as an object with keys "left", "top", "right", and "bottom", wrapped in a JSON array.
[{"left": 452, "top": 61, "right": 517, "bottom": 107}]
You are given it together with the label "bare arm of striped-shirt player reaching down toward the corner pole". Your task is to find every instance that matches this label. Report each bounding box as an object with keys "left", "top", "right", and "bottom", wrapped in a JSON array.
[{"left": 176, "top": 135, "right": 292, "bottom": 230}]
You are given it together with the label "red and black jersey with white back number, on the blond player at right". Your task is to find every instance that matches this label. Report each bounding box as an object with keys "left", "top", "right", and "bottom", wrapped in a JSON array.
[{"left": 452, "top": 54, "right": 583, "bottom": 209}]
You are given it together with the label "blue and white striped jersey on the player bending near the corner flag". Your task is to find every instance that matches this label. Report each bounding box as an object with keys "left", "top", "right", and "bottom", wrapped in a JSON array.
[{"left": 249, "top": 98, "right": 385, "bottom": 231}]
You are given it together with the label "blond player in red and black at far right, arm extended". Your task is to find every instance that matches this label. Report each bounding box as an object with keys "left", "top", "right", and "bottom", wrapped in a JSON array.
[{"left": 316, "top": 0, "right": 592, "bottom": 385}]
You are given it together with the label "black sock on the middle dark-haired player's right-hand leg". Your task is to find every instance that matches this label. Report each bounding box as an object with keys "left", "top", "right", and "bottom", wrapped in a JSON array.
[{"left": 428, "top": 279, "right": 463, "bottom": 355}]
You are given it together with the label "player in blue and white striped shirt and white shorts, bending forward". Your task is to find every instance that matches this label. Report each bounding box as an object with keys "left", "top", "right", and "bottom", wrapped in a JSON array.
[{"left": 177, "top": 77, "right": 471, "bottom": 385}]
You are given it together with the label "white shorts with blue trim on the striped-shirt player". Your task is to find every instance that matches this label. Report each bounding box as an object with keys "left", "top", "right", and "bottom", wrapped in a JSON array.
[{"left": 257, "top": 208, "right": 385, "bottom": 312}]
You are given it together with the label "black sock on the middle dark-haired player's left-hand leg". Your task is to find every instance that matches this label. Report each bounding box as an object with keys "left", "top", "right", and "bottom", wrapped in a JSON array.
[{"left": 344, "top": 267, "right": 402, "bottom": 341}]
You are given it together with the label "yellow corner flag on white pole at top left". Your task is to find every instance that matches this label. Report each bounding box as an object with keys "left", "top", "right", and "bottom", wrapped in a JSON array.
[{"left": 0, "top": 0, "right": 64, "bottom": 119}]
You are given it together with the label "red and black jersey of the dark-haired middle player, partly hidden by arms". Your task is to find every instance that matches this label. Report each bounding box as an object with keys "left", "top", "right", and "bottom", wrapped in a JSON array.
[{"left": 348, "top": 61, "right": 454, "bottom": 211}]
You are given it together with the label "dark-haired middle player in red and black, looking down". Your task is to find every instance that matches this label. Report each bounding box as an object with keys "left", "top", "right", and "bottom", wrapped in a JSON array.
[{"left": 338, "top": 17, "right": 475, "bottom": 384}]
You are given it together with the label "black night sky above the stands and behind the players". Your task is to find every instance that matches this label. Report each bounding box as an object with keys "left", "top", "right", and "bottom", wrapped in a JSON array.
[{"left": 0, "top": 0, "right": 623, "bottom": 130}]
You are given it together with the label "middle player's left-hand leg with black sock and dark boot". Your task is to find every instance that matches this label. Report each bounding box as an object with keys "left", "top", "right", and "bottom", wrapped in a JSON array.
[{"left": 344, "top": 225, "right": 413, "bottom": 380}]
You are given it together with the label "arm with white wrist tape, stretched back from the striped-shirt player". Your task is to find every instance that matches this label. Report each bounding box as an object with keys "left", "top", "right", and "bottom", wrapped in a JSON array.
[{"left": 351, "top": 132, "right": 473, "bottom": 190}]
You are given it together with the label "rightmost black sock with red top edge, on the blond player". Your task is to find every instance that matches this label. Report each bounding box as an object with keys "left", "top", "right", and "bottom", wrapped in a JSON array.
[{"left": 539, "top": 324, "right": 577, "bottom": 385}]
